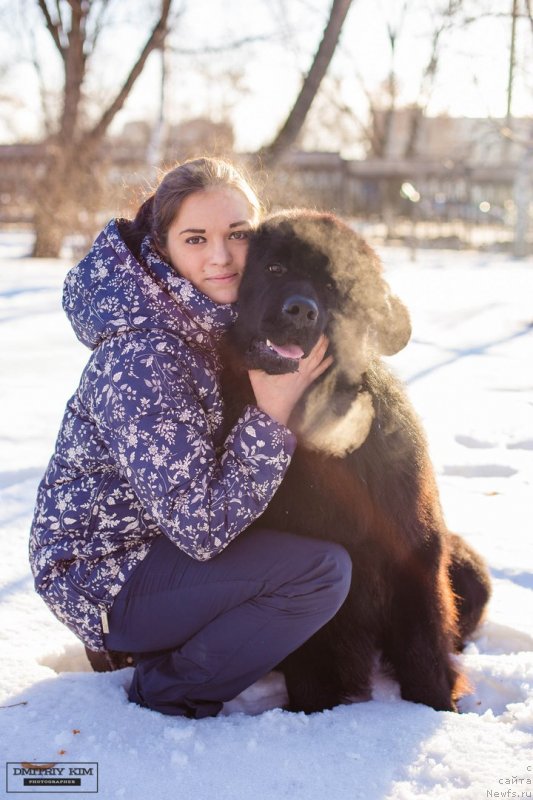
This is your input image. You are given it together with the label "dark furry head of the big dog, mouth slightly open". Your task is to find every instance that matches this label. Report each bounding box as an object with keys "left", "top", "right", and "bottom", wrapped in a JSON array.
[{"left": 231, "top": 209, "right": 411, "bottom": 378}]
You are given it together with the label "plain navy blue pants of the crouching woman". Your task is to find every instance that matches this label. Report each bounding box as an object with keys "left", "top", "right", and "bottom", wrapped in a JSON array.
[{"left": 105, "top": 528, "right": 352, "bottom": 718}]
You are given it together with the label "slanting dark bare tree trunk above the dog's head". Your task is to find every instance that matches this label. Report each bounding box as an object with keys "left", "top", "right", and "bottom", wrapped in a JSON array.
[{"left": 258, "top": 0, "right": 352, "bottom": 166}]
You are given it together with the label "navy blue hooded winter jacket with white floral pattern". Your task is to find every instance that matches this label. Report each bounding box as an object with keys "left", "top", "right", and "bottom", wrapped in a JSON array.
[{"left": 29, "top": 220, "right": 296, "bottom": 651}]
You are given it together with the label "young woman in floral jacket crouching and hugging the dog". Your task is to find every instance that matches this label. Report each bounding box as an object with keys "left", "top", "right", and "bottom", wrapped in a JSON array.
[{"left": 30, "top": 158, "right": 351, "bottom": 718}]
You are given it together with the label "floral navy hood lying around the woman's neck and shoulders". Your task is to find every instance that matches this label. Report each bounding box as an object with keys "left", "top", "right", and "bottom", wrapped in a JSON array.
[{"left": 63, "top": 220, "right": 237, "bottom": 350}]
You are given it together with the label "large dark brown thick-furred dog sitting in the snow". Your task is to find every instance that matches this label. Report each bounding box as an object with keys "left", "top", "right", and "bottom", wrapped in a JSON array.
[{"left": 223, "top": 210, "right": 490, "bottom": 712}]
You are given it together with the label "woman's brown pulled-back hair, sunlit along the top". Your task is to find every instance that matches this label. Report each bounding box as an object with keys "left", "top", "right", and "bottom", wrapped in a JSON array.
[{"left": 120, "top": 157, "right": 262, "bottom": 255}]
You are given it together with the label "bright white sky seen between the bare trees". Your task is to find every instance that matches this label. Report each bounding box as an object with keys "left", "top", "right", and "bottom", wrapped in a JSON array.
[{"left": 0, "top": 0, "right": 533, "bottom": 150}]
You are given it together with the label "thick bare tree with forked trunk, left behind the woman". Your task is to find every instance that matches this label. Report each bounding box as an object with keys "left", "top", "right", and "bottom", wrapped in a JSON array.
[{"left": 34, "top": 0, "right": 172, "bottom": 256}]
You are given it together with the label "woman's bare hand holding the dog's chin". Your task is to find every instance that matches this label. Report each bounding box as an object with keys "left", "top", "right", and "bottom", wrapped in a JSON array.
[{"left": 248, "top": 334, "right": 333, "bottom": 425}]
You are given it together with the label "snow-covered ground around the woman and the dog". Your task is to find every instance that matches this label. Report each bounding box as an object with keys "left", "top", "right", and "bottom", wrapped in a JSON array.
[{"left": 0, "top": 236, "right": 533, "bottom": 800}]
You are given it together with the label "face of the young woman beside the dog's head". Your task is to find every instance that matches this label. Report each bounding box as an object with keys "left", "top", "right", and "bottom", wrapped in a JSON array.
[{"left": 165, "top": 187, "right": 253, "bottom": 303}]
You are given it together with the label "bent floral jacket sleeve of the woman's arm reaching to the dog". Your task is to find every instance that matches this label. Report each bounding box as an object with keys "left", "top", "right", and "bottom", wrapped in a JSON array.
[{"left": 87, "top": 340, "right": 296, "bottom": 561}]
